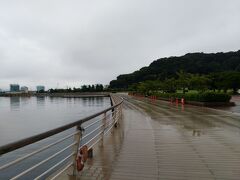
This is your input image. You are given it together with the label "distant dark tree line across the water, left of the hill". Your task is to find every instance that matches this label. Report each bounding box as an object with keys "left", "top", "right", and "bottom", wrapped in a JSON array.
[{"left": 49, "top": 84, "right": 104, "bottom": 93}]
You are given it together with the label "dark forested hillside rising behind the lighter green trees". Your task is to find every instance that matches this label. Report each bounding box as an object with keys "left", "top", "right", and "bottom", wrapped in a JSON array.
[{"left": 110, "top": 50, "right": 240, "bottom": 89}]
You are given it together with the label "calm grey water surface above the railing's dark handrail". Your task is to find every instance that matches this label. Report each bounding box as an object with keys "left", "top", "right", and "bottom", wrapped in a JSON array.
[{"left": 0, "top": 97, "right": 110, "bottom": 146}]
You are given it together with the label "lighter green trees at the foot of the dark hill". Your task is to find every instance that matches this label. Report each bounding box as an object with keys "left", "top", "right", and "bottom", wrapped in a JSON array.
[{"left": 128, "top": 70, "right": 240, "bottom": 95}]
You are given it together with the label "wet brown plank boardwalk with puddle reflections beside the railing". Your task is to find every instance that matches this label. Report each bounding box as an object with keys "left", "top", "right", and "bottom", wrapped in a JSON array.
[{"left": 59, "top": 96, "right": 240, "bottom": 180}]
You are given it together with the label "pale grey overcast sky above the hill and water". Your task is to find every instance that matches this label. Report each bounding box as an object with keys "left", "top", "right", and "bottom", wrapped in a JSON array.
[{"left": 0, "top": 0, "right": 240, "bottom": 89}]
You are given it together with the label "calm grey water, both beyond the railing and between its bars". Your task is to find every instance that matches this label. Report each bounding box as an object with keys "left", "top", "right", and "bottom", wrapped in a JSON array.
[{"left": 0, "top": 97, "right": 110, "bottom": 179}]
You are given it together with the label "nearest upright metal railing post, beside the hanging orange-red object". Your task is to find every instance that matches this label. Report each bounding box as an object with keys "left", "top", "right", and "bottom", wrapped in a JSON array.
[{"left": 72, "top": 126, "right": 82, "bottom": 176}]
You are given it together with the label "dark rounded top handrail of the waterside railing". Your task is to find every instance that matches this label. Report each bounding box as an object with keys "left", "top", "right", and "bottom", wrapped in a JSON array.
[{"left": 0, "top": 97, "right": 123, "bottom": 155}]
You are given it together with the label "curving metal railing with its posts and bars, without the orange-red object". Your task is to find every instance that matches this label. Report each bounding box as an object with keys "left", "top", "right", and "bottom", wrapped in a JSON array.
[{"left": 0, "top": 96, "right": 123, "bottom": 180}]
